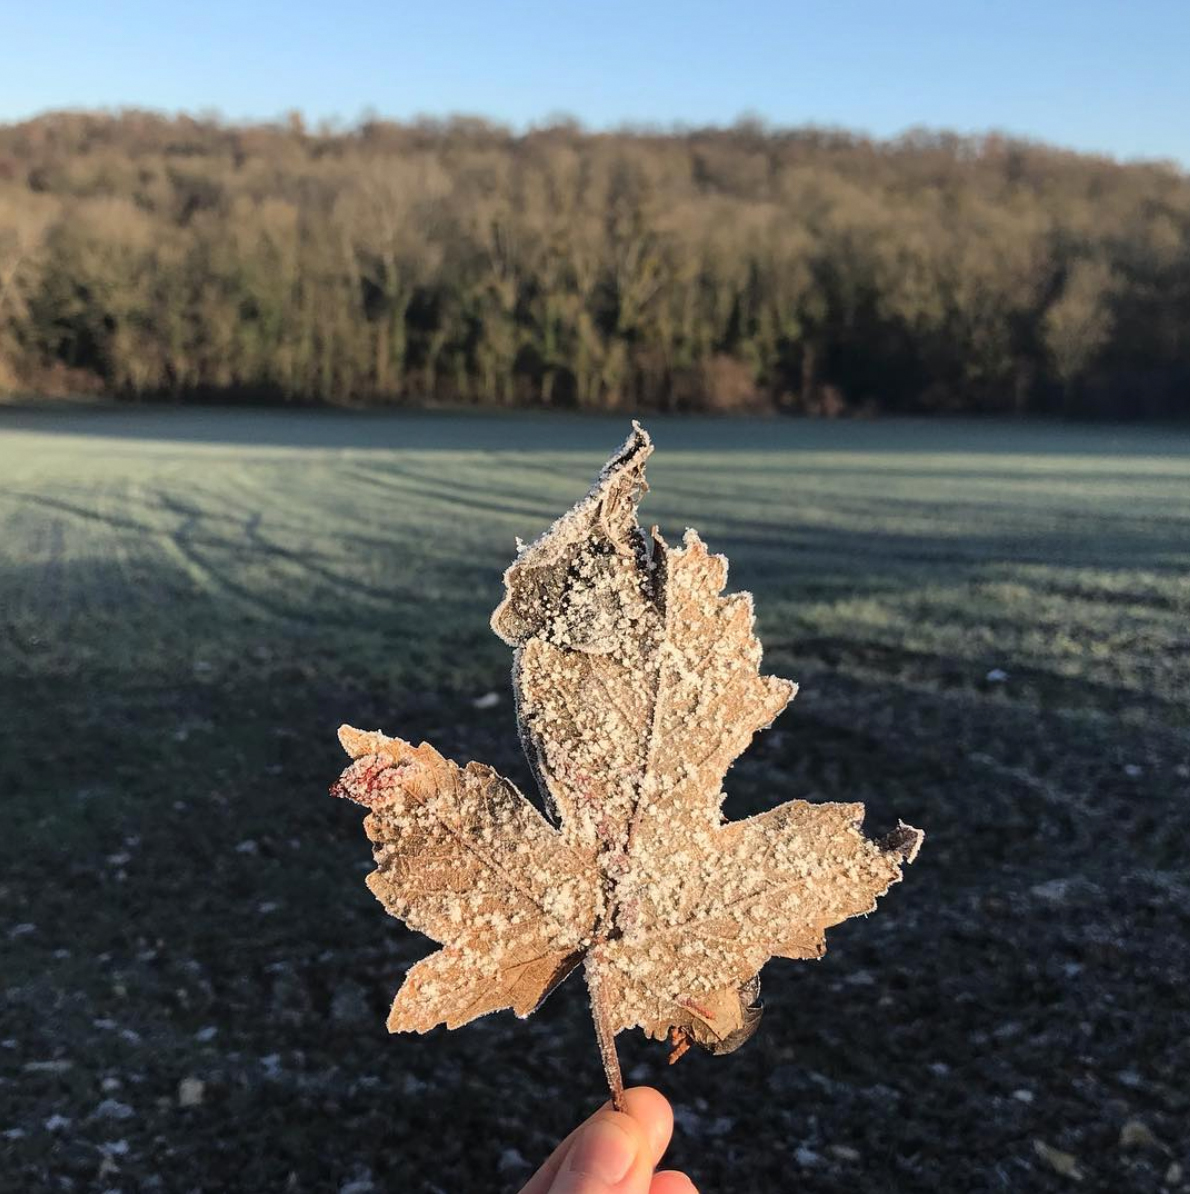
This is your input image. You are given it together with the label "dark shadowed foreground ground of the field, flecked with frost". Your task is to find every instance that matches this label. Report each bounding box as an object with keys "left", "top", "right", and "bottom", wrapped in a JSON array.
[{"left": 0, "top": 611, "right": 1190, "bottom": 1190}]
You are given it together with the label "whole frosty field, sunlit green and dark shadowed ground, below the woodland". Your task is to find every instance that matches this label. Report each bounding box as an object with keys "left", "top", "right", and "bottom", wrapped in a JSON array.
[{"left": 0, "top": 410, "right": 1190, "bottom": 1190}]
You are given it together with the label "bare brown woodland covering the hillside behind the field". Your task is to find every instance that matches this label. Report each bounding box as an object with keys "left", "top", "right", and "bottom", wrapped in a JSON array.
[{"left": 0, "top": 112, "right": 1190, "bottom": 416}]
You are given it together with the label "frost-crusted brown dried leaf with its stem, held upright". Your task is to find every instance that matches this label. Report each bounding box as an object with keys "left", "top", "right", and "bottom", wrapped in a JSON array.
[{"left": 333, "top": 424, "right": 921, "bottom": 1101}]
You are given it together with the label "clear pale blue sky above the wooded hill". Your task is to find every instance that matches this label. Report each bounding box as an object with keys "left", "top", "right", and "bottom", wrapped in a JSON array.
[{"left": 9, "top": 0, "right": 1190, "bottom": 165}]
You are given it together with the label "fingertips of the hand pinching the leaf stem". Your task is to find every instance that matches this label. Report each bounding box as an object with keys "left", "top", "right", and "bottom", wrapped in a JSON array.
[{"left": 520, "top": 1087, "right": 698, "bottom": 1194}]
